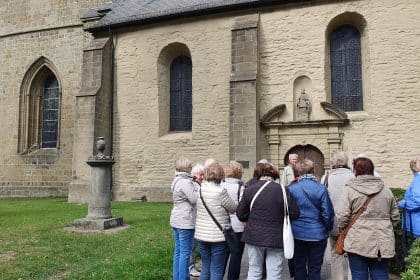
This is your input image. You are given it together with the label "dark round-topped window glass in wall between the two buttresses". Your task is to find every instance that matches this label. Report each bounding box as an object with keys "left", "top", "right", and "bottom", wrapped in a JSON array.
[{"left": 169, "top": 56, "right": 192, "bottom": 131}]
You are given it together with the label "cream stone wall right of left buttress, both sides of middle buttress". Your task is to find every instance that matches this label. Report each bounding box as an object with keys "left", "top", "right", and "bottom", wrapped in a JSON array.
[{"left": 114, "top": 0, "right": 420, "bottom": 200}]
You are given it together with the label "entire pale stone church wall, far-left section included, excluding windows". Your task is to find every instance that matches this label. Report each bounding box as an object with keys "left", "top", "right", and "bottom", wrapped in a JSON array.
[{"left": 0, "top": 0, "right": 420, "bottom": 200}]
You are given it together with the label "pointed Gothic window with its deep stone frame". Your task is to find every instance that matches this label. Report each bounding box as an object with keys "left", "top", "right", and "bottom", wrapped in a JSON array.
[{"left": 18, "top": 57, "right": 61, "bottom": 154}]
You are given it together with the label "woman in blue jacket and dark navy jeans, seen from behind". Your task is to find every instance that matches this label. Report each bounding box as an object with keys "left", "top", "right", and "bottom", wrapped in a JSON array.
[{"left": 289, "top": 159, "right": 334, "bottom": 280}]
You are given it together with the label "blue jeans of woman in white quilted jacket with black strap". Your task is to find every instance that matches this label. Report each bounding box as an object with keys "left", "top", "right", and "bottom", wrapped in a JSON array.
[{"left": 198, "top": 240, "right": 226, "bottom": 280}]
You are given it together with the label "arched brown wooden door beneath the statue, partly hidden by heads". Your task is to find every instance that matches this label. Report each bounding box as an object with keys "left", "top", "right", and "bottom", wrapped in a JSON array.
[{"left": 284, "top": 145, "right": 324, "bottom": 181}]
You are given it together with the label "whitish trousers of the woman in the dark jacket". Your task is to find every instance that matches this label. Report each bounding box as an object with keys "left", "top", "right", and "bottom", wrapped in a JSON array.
[{"left": 247, "top": 244, "right": 284, "bottom": 280}]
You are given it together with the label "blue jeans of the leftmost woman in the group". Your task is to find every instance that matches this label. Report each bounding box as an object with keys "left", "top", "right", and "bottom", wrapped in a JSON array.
[{"left": 172, "top": 228, "right": 194, "bottom": 280}]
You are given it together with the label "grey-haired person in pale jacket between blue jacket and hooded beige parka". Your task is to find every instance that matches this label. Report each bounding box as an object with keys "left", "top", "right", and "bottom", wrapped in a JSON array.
[{"left": 321, "top": 151, "right": 354, "bottom": 280}]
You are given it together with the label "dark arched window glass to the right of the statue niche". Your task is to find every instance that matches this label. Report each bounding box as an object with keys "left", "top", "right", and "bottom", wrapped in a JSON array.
[{"left": 330, "top": 25, "right": 363, "bottom": 111}]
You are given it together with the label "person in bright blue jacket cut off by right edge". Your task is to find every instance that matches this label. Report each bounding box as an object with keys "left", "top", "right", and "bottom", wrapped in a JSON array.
[{"left": 398, "top": 158, "right": 420, "bottom": 238}]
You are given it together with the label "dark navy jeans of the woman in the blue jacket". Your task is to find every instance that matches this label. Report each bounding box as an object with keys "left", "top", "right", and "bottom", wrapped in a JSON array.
[{"left": 293, "top": 239, "right": 327, "bottom": 280}]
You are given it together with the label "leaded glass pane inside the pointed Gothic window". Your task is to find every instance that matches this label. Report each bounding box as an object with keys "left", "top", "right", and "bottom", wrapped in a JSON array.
[{"left": 41, "top": 75, "right": 60, "bottom": 148}]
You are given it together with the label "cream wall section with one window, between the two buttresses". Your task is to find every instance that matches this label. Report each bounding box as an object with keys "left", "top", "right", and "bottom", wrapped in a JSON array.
[{"left": 114, "top": 16, "right": 231, "bottom": 199}]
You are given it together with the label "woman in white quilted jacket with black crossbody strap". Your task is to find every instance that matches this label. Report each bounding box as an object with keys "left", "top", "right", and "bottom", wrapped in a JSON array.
[{"left": 195, "top": 162, "right": 237, "bottom": 280}]
